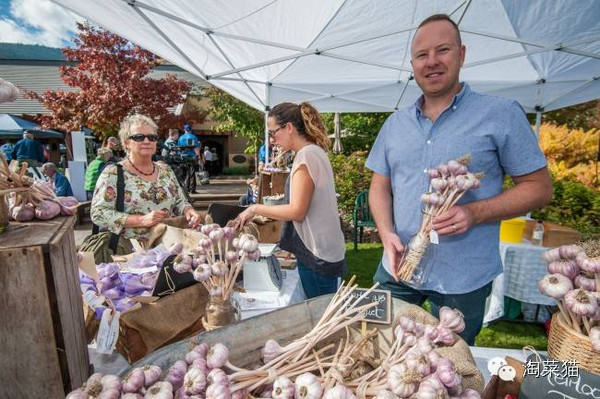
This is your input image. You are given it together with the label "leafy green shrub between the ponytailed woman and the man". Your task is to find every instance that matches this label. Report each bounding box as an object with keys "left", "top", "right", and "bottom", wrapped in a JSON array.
[{"left": 329, "top": 151, "right": 373, "bottom": 221}]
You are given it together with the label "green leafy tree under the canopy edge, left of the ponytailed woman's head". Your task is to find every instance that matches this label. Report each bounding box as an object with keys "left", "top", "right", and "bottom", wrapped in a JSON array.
[{"left": 202, "top": 86, "right": 265, "bottom": 154}]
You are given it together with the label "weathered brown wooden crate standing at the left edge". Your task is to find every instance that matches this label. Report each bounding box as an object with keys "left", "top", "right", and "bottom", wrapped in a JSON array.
[{"left": 0, "top": 216, "right": 90, "bottom": 398}]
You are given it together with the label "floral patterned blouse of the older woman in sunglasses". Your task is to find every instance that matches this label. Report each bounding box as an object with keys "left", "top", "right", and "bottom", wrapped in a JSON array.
[{"left": 91, "top": 163, "right": 191, "bottom": 245}]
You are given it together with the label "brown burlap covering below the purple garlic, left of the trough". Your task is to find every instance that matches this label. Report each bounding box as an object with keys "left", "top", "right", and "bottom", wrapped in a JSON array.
[{"left": 117, "top": 284, "right": 208, "bottom": 363}]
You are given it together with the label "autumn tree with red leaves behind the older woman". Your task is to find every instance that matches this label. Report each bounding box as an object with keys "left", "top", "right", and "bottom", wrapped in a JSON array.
[{"left": 27, "top": 24, "right": 197, "bottom": 137}]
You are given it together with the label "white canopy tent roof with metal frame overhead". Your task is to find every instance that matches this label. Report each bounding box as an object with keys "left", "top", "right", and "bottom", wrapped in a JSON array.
[{"left": 52, "top": 0, "right": 600, "bottom": 156}]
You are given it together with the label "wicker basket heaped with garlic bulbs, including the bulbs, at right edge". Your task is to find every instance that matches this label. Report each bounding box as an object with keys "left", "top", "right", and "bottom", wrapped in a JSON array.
[{"left": 539, "top": 241, "right": 600, "bottom": 374}]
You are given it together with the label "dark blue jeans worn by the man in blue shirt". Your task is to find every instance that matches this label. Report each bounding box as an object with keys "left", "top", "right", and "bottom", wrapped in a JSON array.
[{"left": 373, "top": 263, "right": 492, "bottom": 346}]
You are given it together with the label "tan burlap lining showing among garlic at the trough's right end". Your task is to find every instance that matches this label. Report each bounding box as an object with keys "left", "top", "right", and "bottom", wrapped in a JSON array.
[{"left": 393, "top": 305, "right": 485, "bottom": 394}]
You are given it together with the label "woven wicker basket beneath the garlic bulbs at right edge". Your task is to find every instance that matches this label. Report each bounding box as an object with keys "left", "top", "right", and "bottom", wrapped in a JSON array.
[{"left": 548, "top": 313, "right": 600, "bottom": 374}]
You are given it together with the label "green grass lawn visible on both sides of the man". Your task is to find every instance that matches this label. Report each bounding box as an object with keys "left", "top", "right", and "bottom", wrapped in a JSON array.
[{"left": 345, "top": 243, "right": 548, "bottom": 350}]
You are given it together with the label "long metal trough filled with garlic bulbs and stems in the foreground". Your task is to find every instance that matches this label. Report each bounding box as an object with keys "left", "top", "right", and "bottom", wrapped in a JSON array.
[{"left": 69, "top": 285, "right": 483, "bottom": 398}]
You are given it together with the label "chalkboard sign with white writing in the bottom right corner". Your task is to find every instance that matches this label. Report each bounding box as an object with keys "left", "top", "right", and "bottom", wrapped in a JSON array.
[{"left": 519, "top": 355, "right": 600, "bottom": 399}]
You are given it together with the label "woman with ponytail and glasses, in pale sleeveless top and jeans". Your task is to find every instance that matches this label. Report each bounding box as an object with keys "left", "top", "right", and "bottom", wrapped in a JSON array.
[{"left": 236, "top": 102, "right": 346, "bottom": 298}]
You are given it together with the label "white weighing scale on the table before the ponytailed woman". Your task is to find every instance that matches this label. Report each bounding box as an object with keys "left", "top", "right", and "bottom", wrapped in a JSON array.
[{"left": 243, "top": 244, "right": 283, "bottom": 292}]
